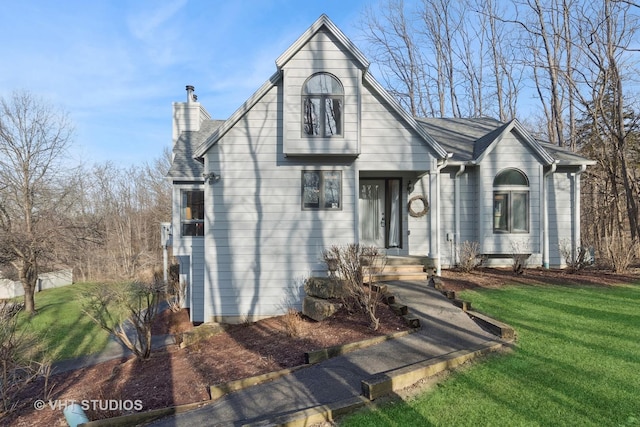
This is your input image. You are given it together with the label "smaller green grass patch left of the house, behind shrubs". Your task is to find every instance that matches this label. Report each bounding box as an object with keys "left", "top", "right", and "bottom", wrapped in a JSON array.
[{"left": 19, "top": 283, "right": 117, "bottom": 361}]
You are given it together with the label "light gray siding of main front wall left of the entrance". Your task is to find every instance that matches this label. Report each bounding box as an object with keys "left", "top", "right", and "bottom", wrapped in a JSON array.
[{"left": 204, "top": 87, "right": 357, "bottom": 320}]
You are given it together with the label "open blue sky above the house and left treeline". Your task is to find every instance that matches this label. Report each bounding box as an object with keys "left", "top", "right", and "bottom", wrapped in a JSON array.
[{"left": 0, "top": 0, "right": 375, "bottom": 166}]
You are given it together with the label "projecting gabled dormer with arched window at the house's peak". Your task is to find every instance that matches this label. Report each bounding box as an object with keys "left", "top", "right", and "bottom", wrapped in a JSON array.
[{"left": 276, "top": 15, "right": 369, "bottom": 157}]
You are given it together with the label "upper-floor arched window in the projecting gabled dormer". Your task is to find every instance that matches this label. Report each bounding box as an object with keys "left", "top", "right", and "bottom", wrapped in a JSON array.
[{"left": 302, "top": 73, "right": 344, "bottom": 137}]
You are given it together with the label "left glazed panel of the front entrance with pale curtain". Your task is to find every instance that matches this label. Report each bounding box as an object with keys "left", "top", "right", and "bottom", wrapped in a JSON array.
[{"left": 359, "top": 179, "right": 386, "bottom": 248}]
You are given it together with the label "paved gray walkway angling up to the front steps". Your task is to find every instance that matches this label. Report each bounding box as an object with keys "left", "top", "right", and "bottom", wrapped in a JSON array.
[{"left": 138, "top": 282, "right": 499, "bottom": 427}]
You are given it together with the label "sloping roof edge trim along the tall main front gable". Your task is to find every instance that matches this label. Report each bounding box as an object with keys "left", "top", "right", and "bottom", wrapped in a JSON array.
[{"left": 193, "top": 14, "right": 449, "bottom": 160}]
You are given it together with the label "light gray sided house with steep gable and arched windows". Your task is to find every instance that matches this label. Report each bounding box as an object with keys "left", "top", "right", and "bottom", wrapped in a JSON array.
[{"left": 169, "top": 15, "right": 592, "bottom": 322}]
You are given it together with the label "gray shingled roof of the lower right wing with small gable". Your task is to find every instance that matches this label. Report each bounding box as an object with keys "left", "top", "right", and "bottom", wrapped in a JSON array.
[{"left": 418, "top": 118, "right": 594, "bottom": 165}]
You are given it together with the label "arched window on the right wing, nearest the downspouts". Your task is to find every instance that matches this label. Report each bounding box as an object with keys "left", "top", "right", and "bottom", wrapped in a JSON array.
[{"left": 493, "top": 169, "right": 529, "bottom": 233}]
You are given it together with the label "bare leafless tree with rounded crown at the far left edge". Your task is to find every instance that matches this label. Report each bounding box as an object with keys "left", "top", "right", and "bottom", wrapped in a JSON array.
[{"left": 0, "top": 92, "right": 73, "bottom": 313}]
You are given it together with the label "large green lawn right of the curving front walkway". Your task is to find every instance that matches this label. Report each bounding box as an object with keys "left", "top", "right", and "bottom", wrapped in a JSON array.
[{"left": 340, "top": 285, "right": 640, "bottom": 427}]
